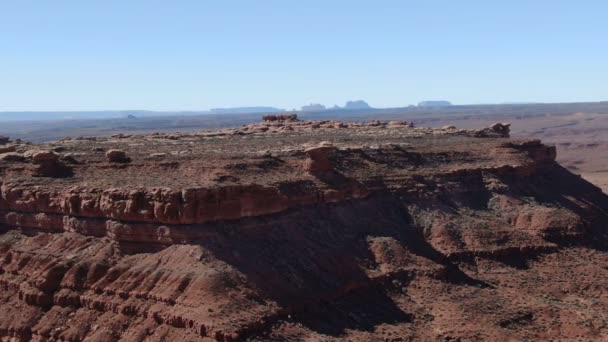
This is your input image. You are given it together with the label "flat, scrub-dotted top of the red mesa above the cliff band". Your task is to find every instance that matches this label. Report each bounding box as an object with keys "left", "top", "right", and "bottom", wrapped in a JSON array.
[{"left": 0, "top": 119, "right": 526, "bottom": 189}]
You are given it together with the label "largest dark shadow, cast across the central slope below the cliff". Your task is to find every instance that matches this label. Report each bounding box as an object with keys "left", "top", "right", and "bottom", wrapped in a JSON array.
[{"left": 190, "top": 196, "right": 480, "bottom": 336}]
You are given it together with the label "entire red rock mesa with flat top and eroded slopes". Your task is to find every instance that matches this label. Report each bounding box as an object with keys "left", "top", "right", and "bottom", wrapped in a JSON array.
[{"left": 0, "top": 119, "right": 608, "bottom": 341}]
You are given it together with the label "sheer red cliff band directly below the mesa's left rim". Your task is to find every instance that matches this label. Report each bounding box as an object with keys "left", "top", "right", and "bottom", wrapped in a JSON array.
[{"left": 0, "top": 185, "right": 360, "bottom": 224}]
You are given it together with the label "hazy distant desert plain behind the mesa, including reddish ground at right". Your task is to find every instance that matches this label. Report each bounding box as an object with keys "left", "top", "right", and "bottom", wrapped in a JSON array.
[{"left": 0, "top": 102, "right": 608, "bottom": 191}]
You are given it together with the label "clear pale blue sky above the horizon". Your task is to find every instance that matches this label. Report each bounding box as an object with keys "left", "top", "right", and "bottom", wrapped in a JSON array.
[{"left": 0, "top": 0, "right": 608, "bottom": 111}]
